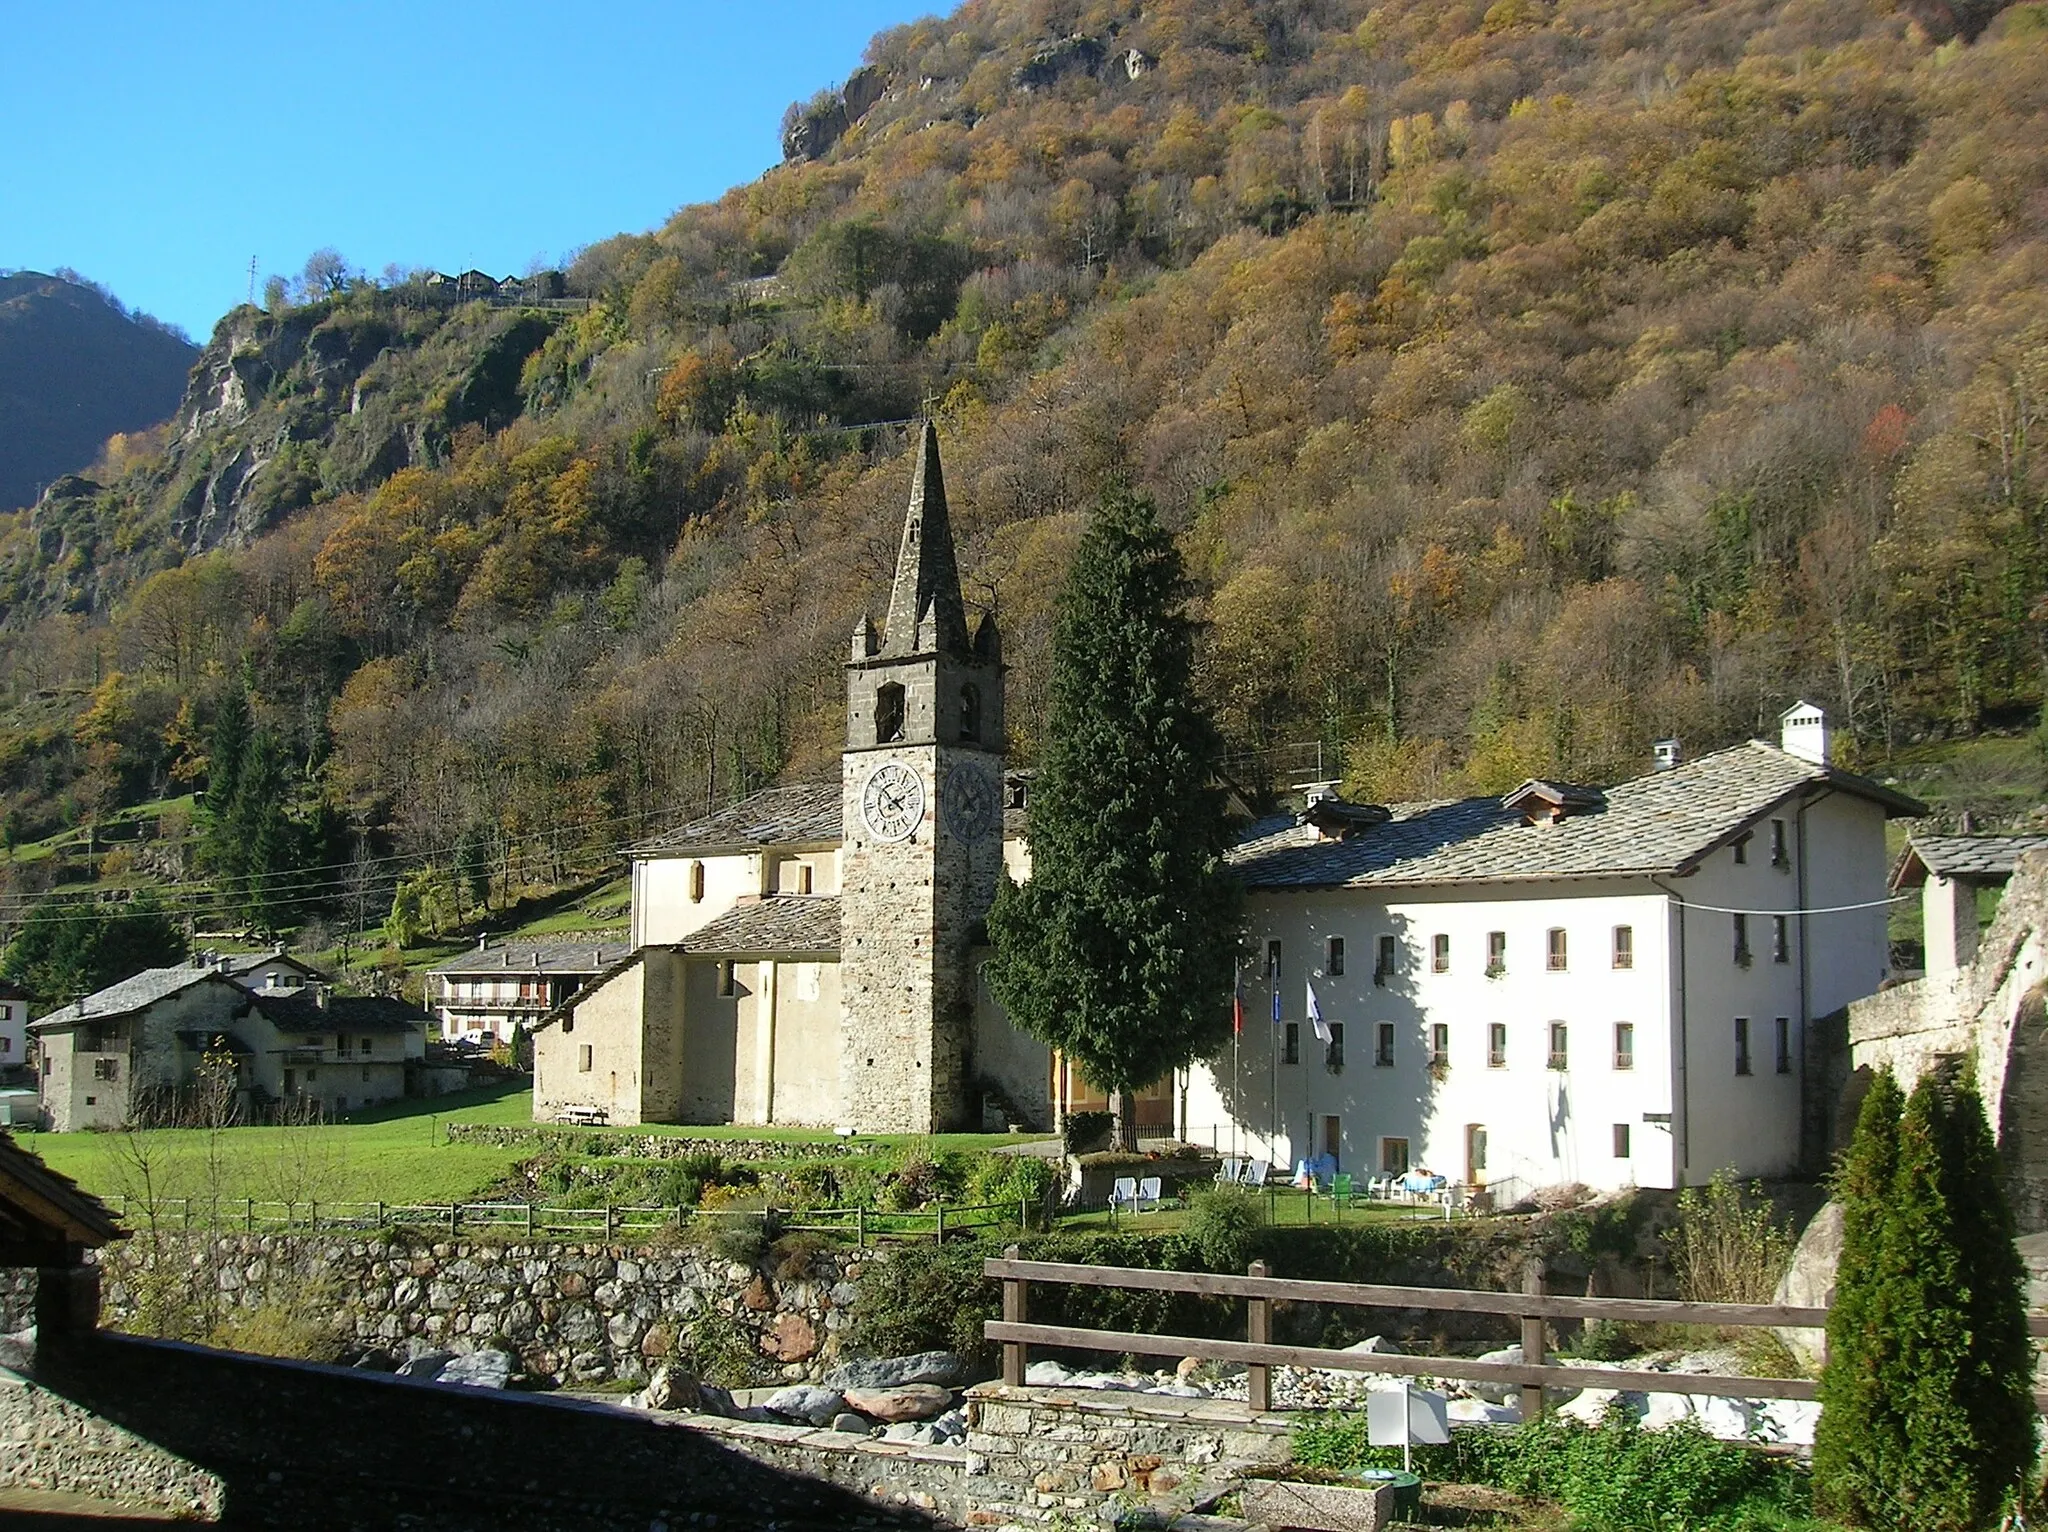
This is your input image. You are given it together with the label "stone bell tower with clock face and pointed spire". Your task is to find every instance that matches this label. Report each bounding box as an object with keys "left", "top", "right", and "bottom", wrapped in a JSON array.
[{"left": 840, "top": 422, "right": 1004, "bottom": 1133}]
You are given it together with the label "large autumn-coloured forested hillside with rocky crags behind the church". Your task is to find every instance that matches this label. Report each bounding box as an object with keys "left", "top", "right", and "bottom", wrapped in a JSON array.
[{"left": 0, "top": 0, "right": 2048, "bottom": 950}]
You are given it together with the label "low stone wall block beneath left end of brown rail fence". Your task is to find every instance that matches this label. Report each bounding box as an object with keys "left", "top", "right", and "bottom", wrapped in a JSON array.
[{"left": 967, "top": 1382, "right": 1292, "bottom": 1526}]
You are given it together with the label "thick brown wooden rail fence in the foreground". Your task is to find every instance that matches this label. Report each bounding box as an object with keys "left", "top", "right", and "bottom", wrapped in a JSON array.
[{"left": 983, "top": 1245, "right": 2048, "bottom": 1419}]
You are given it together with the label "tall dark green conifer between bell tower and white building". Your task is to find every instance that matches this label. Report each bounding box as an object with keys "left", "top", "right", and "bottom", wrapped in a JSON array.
[{"left": 985, "top": 490, "right": 1241, "bottom": 1149}]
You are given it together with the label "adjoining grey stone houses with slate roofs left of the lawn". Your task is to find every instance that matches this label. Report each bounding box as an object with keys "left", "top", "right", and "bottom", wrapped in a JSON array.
[{"left": 29, "top": 961, "right": 428, "bottom": 1133}]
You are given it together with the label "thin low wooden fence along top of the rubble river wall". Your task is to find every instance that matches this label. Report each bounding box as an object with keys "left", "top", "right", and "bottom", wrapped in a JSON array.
[{"left": 100, "top": 1196, "right": 1042, "bottom": 1247}]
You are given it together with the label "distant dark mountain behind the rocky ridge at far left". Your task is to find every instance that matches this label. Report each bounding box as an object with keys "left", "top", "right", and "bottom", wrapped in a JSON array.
[{"left": 0, "top": 272, "right": 199, "bottom": 510}]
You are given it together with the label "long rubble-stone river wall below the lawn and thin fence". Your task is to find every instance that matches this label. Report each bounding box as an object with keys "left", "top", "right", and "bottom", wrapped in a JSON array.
[{"left": 61, "top": 1231, "right": 887, "bottom": 1387}]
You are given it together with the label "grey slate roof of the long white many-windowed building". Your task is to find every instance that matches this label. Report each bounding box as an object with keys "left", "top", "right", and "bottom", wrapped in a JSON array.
[{"left": 1231, "top": 739, "right": 1927, "bottom": 889}]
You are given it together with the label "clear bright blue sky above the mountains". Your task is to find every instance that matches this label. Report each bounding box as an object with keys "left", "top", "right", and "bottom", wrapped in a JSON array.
[{"left": 0, "top": 0, "right": 933, "bottom": 340}]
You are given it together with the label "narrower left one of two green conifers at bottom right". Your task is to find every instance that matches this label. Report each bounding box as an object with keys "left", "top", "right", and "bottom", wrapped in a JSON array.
[{"left": 1812, "top": 1069, "right": 1905, "bottom": 1526}]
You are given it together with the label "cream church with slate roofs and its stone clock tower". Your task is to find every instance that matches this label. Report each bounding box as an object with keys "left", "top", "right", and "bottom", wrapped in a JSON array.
[{"left": 535, "top": 424, "right": 1051, "bottom": 1133}]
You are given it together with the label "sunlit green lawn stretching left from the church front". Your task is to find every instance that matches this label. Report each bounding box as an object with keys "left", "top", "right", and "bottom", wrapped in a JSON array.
[{"left": 16, "top": 1088, "right": 1056, "bottom": 1202}]
